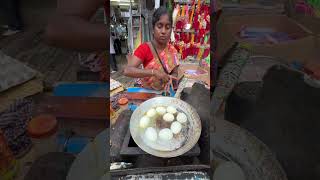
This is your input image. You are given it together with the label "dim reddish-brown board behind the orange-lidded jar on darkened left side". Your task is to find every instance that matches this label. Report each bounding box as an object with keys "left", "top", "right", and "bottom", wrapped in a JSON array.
[{"left": 34, "top": 96, "right": 110, "bottom": 137}]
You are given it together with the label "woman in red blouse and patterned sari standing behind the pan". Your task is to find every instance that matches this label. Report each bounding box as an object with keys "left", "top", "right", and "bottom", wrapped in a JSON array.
[{"left": 124, "top": 7, "right": 179, "bottom": 91}]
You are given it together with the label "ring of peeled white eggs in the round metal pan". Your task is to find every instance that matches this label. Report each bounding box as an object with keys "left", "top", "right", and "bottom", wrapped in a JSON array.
[{"left": 139, "top": 106, "right": 188, "bottom": 142}]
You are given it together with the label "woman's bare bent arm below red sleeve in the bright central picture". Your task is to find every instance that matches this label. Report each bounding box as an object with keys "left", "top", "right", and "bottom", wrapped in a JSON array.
[{"left": 124, "top": 56, "right": 169, "bottom": 81}]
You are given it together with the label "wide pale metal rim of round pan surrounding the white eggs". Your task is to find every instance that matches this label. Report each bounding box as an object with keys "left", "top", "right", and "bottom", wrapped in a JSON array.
[{"left": 130, "top": 97, "right": 202, "bottom": 158}]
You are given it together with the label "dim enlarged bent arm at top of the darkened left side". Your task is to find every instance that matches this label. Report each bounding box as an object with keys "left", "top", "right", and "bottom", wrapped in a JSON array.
[{"left": 45, "top": 0, "right": 109, "bottom": 51}]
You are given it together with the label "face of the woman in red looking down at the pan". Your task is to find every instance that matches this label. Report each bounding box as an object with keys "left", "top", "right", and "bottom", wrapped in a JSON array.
[{"left": 154, "top": 14, "right": 172, "bottom": 44}]
